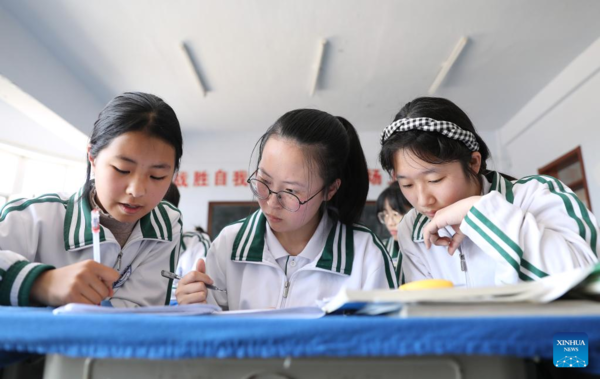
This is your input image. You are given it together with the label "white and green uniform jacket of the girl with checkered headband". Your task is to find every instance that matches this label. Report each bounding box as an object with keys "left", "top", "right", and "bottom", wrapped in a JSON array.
[{"left": 398, "top": 172, "right": 598, "bottom": 287}]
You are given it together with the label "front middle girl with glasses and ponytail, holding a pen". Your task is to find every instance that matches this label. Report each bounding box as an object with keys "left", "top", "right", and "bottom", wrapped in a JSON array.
[{"left": 177, "top": 109, "right": 396, "bottom": 310}]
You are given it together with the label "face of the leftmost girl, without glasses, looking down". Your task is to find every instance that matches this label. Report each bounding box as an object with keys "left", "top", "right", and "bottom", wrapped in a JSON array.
[{"left": 88, "top": 131, "right": 175, "bottom": 222}]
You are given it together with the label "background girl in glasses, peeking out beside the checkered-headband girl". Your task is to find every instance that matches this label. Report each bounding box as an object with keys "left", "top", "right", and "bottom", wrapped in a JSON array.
[{"left": 377, "top": 182, "right": 411, "bottom": 267}]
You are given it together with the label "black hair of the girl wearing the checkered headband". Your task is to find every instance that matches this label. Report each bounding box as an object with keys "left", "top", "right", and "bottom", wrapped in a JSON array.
[{"left": 379, "top": 97, "right": 490, "bottom": 184}]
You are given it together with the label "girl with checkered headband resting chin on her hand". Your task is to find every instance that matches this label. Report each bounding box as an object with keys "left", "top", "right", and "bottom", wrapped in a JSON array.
[{"left": 379, "top": 97, "right": 598, "bottom": 287}]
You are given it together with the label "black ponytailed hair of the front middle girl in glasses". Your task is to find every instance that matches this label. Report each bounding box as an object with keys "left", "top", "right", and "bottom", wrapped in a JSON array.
[{"left": 257, "top": 109, "right": 369, "bottom": 225}]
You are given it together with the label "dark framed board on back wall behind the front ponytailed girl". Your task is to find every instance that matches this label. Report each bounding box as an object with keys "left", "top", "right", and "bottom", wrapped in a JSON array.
[{"left": 207, "top": 201, "right": 389, "bottom": 240}]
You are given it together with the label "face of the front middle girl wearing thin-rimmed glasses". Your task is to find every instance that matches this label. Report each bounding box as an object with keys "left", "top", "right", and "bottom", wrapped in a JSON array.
[{"left": 256, "top": 136, "right": 339, "bottom": 233}]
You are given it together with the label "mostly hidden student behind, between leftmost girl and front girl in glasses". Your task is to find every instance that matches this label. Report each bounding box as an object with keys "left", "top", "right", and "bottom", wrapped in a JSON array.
[{"left": 163, "top": 183, "right": 210, "bottom": 305}]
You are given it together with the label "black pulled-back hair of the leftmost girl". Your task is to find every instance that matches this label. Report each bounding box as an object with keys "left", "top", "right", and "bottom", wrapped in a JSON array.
[{"left": 83, "top": 92, "right": 183, "bottom": 198}]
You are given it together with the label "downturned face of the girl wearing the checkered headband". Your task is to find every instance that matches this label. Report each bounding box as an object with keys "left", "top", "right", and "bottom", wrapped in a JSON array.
[{"left": 394, "top": 149, "right": 481, "bottom": 218}]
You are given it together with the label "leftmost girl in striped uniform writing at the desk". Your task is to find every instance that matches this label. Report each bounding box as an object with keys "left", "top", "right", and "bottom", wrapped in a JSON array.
[{"left": 0, "top": 92, "right": 182, "bottom": 307}]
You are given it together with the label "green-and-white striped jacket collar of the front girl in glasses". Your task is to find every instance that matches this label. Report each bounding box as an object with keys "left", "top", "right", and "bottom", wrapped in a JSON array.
[{"left": 231, "top": 210, "right": 354, "bottom": 275}]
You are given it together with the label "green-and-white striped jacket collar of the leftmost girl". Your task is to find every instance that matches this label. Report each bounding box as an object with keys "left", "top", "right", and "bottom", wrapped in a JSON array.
[{"left": 63, "top": 188, "right": 173, "bottom": 251}]
